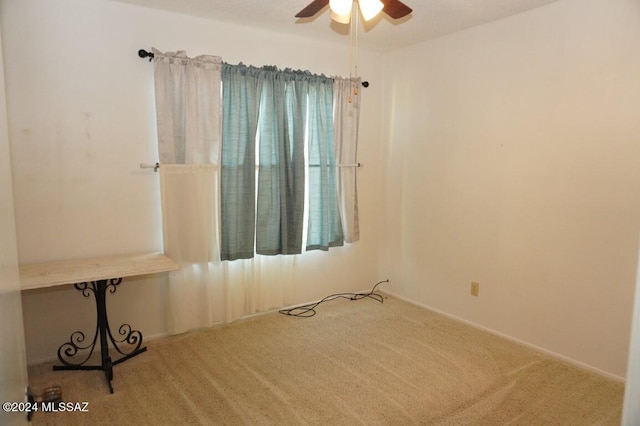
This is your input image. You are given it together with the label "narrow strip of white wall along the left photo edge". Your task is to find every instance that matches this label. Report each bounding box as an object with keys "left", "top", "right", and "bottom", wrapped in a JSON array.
[{"left": 0, "top": 17, "right": 27, "bottom": 425}]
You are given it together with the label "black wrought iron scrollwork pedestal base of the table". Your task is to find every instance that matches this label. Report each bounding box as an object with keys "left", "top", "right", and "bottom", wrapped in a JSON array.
[{"left": 53, "top": 278, "right": 147, "bottom": 393}]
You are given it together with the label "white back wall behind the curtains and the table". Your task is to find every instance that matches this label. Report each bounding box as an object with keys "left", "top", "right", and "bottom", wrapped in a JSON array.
[{"left": 2, "top": 0, "right": 382, "bottom": 363}]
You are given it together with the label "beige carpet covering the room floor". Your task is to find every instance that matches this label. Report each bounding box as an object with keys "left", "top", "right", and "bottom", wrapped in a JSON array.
[{"left": 29, "top": 297, "right": 624, "bottom": 426}]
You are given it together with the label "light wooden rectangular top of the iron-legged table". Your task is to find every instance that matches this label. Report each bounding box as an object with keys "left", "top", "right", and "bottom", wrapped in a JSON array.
[{"left": 20, "top": 253, "right": 180, "bottom": 290}]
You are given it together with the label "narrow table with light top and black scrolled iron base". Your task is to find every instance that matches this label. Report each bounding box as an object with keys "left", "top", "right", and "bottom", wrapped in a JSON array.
[{"left": 20, "top": 253, "right": 180, "bottom": 393}]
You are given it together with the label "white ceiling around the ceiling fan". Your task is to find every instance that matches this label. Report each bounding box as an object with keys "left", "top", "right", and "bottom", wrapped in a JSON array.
[{"left": 110, "top": 0, "right": 558, "bottom": 52}]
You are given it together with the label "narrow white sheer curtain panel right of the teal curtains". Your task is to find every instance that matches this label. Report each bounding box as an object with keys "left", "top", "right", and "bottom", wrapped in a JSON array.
[{"left": 333, "top": 77, "right": 362, "bottom": 243}]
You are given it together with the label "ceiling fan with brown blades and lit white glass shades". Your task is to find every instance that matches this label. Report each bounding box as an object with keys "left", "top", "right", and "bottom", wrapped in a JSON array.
[{"left": 296, "top": 0, "right": 413, "bottom": 24}]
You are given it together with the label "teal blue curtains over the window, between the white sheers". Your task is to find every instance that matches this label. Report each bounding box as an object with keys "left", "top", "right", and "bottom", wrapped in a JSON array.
[{"left": 220, "top": 64, "right": 343, "bottom": 260}]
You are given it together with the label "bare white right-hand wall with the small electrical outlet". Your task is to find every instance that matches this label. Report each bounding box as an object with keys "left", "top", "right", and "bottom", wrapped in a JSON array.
[{"left": 380, "top": 0, "right": 640, "bottom": 378}]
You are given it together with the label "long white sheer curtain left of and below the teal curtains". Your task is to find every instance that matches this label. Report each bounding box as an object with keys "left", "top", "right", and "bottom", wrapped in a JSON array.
[{"left": 153, "top": 49, "right": 295, "bottom": 334}]
